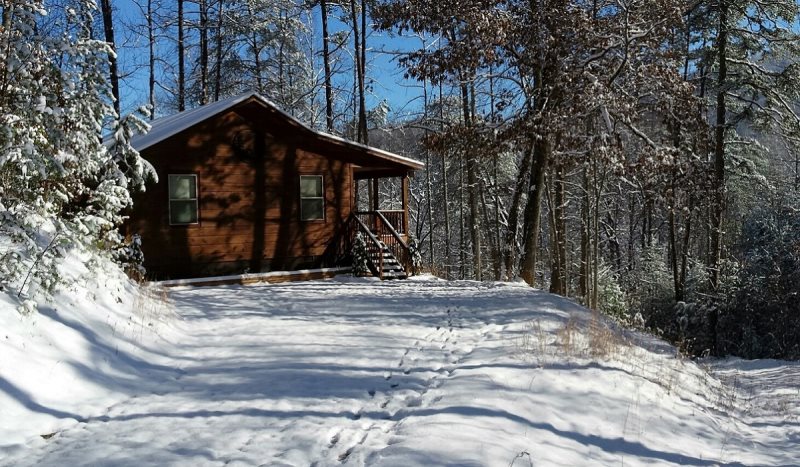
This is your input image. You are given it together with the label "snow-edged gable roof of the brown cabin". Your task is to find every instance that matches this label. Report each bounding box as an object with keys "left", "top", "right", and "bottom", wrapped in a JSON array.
[{"left": 131, "top": 92, "right": 425, "bottom": 170}]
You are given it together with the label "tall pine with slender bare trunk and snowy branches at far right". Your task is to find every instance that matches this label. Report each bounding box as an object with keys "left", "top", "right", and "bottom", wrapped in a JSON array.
[{"left": 689, "top": 0, "right": 800, "bottom": 288}]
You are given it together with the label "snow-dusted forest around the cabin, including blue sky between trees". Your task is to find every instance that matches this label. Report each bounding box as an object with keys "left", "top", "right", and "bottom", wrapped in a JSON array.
[{"left": 0, "top": 0, "right": 800, "bottom": 359}]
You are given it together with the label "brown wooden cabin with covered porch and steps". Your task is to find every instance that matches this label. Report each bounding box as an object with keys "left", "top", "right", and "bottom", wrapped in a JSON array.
[{"left": 126, "top": 93, "right": 423, "bottom": 279}]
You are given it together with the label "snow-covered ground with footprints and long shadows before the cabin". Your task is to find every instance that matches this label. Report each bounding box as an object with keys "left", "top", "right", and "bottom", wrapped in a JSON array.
[{"left": 0, "top": 277, "right": 800, "bottom": 466}]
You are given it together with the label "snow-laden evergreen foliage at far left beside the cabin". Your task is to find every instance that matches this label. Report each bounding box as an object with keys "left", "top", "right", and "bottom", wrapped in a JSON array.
[{"left": 0, "top": 0, "right": 151, "bottom": 304}]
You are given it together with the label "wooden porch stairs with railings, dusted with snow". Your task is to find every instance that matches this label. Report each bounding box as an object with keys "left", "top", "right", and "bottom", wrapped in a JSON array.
[{"left": 347, "top": 211, "right": 411, "bottom": 280}]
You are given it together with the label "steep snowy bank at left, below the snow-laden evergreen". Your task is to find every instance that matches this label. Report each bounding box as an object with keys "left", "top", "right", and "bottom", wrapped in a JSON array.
[{"left": 0, "top": 252, "right": 175, "bottom": 452}]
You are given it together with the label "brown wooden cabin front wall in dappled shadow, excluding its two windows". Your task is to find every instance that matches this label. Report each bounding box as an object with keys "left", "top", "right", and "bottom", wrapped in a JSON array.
[{"left": 128, "top": 101, "right": 352, "bottom": 279}]
